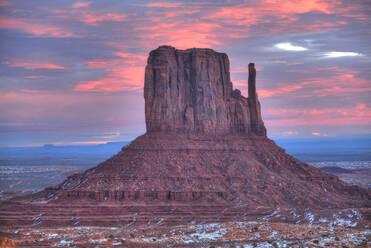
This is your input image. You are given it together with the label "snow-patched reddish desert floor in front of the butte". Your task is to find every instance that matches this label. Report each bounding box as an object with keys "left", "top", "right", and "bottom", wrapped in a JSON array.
[{"left": 2, "top": 222, "right": 371, "bottom": 248}]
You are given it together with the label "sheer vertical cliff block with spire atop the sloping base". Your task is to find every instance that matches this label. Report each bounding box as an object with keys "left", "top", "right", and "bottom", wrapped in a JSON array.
[{"left": 144, "top": 46, "right": 266, "bottom": 136}]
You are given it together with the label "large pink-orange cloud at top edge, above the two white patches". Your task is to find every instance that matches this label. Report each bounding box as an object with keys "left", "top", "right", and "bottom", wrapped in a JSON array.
[{"left": 202, "top": 0, "right": 347, "bottom": 36}]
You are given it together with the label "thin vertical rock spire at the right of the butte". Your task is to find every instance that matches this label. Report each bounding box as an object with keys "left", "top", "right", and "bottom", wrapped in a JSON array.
[{"left": 248, "top": 63, "right": 267, "bottom": 136}]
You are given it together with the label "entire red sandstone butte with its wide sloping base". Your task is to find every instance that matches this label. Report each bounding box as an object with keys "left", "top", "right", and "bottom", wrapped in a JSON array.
[{"left": 0, "top": 46, "right": 370, "bottom": 227}]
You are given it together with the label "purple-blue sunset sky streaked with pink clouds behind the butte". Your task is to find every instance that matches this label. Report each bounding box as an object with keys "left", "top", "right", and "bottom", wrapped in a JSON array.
[{"left": 0, "top": 0, "right": 371, "bottom": 147}]
